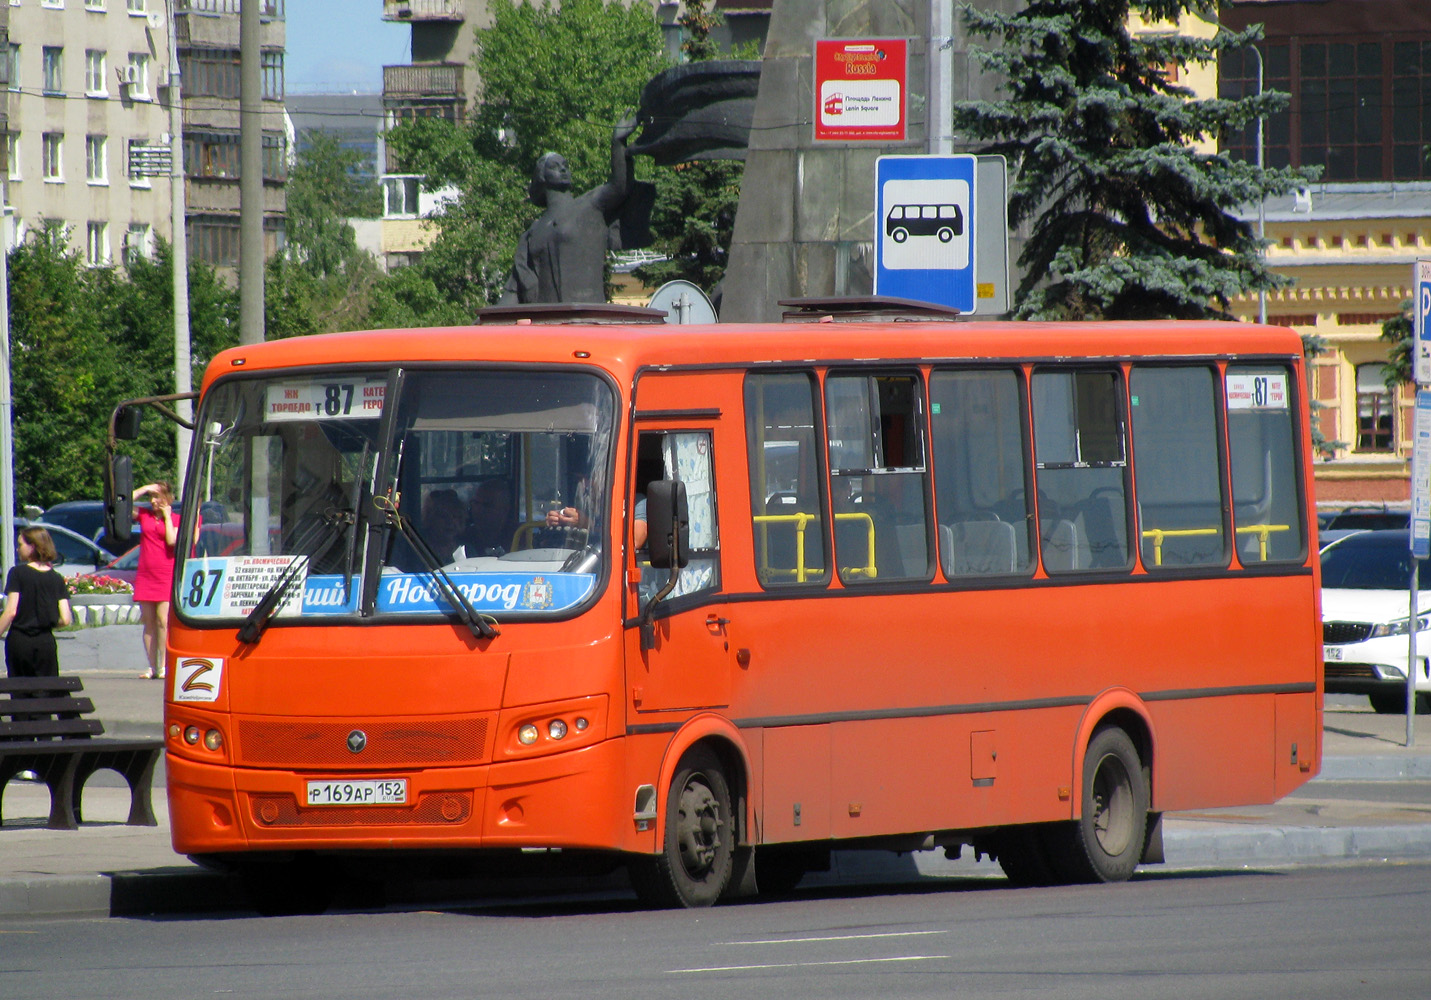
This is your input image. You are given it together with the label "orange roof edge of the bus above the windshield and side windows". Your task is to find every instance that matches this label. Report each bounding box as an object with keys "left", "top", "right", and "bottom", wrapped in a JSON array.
[{"left": 205, "top": 320, "right": 1302, "bottom": 386}]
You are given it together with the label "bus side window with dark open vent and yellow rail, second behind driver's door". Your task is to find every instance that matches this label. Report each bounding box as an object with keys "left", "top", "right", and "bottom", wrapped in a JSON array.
[{"left": 824, "top": 375, "right": 930, "bottom": 584}]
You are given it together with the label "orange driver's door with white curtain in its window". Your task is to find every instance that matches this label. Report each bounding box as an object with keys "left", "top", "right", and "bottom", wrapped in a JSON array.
[{"left": 625, "top": 413, "right": 736, "bottom": 715}]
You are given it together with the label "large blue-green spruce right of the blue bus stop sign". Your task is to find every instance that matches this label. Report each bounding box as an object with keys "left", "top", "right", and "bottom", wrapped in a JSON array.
[{"left": 954, "top": 0, "right": 1311, "bottom": 319}]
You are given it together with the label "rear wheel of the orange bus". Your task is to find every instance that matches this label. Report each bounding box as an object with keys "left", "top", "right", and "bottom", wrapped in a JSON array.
[{"left": 1047, "top": 727, "right": 1149, "bottom": 883}]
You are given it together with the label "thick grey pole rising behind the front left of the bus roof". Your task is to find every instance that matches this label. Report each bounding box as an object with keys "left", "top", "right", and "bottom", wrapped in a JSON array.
[{"left": 239, "top": 0, "right": 263, "bottom": 343}]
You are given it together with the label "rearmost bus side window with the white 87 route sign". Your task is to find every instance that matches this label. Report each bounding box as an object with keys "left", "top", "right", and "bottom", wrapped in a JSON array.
[{"left": 1226, "top": 365, "right": 1307, "bottom": 565}]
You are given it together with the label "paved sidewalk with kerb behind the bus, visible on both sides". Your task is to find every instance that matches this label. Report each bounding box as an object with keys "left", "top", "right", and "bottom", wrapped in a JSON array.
[{"left": 0, "top": 625, "right": 1431, "bottom": 920}]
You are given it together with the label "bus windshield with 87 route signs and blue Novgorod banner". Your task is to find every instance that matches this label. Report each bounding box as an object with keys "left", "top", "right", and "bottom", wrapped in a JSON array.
[{"left": 177, "top": 369, "right": 615, "bottom": 624}]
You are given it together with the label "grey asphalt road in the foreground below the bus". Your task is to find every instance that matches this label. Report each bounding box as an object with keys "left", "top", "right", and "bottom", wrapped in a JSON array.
[{"left": 8, "top": 864, "right": 1431, "bottom": 1000}]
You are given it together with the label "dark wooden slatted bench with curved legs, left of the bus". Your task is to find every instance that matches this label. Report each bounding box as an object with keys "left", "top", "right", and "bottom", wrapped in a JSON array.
[{"left": 0, "top": 677, "right": 165, "bottom": 830}]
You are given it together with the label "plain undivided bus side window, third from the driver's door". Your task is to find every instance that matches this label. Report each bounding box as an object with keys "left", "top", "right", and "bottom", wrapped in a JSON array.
[{"left": 929, "top": 371, "right": 1033, "bottom": 578}]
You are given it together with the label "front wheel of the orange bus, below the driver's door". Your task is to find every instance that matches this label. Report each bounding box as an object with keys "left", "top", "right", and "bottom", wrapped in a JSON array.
[{"left": 628, "top": 747, "right": 736, "bottom": 908}]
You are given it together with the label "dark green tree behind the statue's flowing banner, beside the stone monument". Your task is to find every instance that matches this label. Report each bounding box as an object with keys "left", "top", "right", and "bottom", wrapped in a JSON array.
[{"left": 635, "top": 0, "right": 746, "bottom": 290}]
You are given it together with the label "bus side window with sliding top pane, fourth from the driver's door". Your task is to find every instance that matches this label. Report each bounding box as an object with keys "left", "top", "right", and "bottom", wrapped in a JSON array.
[{"left": 1032, "top": 369, "right": 1130, "bottom": 574}]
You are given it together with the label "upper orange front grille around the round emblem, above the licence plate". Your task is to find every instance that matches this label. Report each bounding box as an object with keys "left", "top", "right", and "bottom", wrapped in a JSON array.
[{"left": 235, "top": 718, "right": 487, "bottom": 770}]
